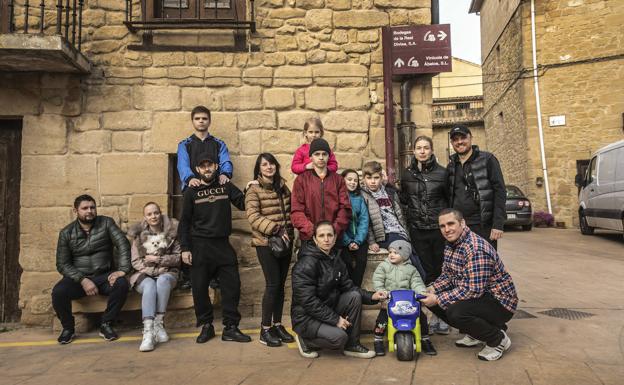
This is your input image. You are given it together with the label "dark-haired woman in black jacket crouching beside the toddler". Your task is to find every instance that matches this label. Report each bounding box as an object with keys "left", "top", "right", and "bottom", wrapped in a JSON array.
[{"left": 291, "top": 221, "right": 385, "bottom": 358}]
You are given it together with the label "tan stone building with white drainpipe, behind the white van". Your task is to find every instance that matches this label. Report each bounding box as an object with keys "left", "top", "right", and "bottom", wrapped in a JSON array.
[{"left": 470, "top": 0, "right": 624, "bottom": 226}]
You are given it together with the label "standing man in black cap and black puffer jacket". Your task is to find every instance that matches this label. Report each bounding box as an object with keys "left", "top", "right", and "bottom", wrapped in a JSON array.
[{"left": 447, "top": 125, "right": 507, "bottom": 248}]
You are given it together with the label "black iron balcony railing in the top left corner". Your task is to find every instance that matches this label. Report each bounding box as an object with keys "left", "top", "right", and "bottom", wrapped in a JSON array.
[{"left": 0, "top": 0, "right": 84, "bottom": 51}]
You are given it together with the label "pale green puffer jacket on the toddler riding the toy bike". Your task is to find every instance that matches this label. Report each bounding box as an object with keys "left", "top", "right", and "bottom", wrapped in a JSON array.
[{"left": 373, "top": 258, "right": 427, "bottom": 294}]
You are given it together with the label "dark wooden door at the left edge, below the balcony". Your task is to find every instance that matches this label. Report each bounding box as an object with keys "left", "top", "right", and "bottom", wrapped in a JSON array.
[{"left": 0, "top": 119, "right": 22, "bottom": 322}]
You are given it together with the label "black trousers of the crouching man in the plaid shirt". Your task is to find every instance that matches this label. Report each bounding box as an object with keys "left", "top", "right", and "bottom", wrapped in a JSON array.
[{"left": 430, "top": 293, "right": 513, "bottom": 347}]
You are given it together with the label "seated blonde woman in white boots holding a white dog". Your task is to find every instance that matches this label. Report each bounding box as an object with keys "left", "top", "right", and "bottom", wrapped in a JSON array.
[{"left": 128, "top": 202, "right": 181, "bottom": 352}]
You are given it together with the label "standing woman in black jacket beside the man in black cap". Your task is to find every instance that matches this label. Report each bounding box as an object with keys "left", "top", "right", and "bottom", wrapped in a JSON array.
[{"left": 400, "top": 136, "right": 449, "bottom": 334}]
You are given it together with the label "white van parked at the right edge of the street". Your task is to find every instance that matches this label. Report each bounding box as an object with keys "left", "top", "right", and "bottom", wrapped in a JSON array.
[{"left": 577, "top": 140, "right": 624, "bottom": 235}]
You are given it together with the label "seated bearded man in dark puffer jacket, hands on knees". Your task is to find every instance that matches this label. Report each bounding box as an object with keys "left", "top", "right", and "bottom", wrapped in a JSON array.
[{"left": 52, "top": 195, "right": 132, "bottom": 344}]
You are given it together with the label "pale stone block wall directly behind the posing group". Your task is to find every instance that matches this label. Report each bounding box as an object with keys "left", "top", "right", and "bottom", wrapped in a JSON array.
[{"left": 0, "top": 0, "right": 431, "bottom": 325}]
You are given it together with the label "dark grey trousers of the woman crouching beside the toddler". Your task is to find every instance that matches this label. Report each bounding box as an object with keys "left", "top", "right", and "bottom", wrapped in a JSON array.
[{"left": 306, "top": 290, "right": 362, "bottom": 350}]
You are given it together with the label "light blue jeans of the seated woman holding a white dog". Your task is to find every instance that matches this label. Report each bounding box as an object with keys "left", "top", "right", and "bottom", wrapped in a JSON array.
[{"left": 136, "top": 274, "right": 176, "bottom": 319}]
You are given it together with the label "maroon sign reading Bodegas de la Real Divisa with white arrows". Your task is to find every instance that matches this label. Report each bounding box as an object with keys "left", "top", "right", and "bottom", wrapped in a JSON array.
[{"left": 383, "top": 24, "right": 452, "bottom": 75}]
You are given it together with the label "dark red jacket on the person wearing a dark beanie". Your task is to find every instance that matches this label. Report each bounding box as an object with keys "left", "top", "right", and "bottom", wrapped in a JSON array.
[{"left": 290, "top": 170, "right": 351, "bottom": 240}]
